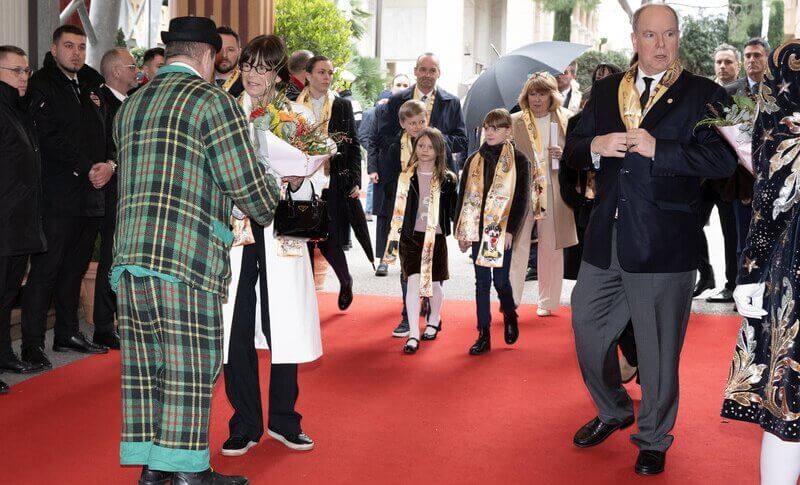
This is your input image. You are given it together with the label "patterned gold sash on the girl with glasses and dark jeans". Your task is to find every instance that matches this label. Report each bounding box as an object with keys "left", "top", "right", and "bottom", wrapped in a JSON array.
[{"left": 455, "top": 141, "right": 517, "bottom": 268}]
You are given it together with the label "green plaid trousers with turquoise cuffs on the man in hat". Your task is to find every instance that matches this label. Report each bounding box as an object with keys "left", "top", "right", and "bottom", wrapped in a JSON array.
[{"left": 117, "top": 272, "right": 222, "bottom": 472}]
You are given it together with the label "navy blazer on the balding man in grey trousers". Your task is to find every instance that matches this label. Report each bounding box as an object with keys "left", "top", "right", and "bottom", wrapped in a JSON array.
[{"left": 564, "top": 71, "right": 736, "bottom": 273}]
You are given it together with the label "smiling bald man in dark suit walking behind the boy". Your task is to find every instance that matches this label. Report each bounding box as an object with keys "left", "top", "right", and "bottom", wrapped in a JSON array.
[{"left": 368, "top": 52, "right": 467, "bottom": 337}]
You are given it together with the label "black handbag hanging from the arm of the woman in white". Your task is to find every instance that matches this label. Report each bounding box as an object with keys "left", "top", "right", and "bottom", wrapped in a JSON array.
[{"left": 275, "top": 181, "right": 329, "bottom": 242}]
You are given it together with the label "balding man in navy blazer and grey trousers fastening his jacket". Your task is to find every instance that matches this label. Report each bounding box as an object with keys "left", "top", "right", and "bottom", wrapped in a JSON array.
[{"left": 564, "top": 4, "right": 736, "bottom": 475}]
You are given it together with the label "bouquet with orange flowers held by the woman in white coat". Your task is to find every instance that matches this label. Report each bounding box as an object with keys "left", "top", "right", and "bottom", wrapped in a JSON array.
[{"left": 250, "top": 91, "right": 343, "bottom": 177}]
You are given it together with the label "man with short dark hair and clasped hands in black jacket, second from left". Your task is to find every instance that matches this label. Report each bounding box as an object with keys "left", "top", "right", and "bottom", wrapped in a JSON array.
[{"left": 22, "top": 25, "right": 110, "bottom": 367}]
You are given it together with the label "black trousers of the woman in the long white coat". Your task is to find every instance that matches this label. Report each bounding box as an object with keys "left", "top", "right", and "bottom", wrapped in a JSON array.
[{"left": 223, "top": 221, "right": 302, "bottom": 441}]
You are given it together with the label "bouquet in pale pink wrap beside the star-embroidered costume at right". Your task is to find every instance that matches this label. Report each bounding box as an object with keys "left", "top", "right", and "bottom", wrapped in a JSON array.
[{"left": 695, "top": 96, "right": 757, "bottom": 175}]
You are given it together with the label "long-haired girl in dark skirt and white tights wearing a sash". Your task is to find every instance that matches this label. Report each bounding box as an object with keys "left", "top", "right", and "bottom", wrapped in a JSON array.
[{"left": 383, "top": 128, "right": 457, "bottom": 354}]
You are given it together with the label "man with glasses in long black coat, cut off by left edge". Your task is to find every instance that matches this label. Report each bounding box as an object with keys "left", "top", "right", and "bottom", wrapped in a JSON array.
[{"left": 0, "top": 45, "right": 47, "bottom": 394}]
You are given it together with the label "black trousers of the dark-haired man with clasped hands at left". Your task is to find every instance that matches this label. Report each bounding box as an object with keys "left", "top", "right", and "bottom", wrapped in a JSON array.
[{"left": 22, "top": 217, "right": 101, "bottom": 350}]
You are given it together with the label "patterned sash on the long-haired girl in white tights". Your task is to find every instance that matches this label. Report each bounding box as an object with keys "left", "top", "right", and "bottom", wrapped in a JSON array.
[{"left": 383, "top": 164, "right": 442, "bottom": 298}]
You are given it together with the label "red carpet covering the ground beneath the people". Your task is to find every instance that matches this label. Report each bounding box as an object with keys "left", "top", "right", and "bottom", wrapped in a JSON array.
[{"left": 0, "top": 294, "right": 760, "bottom": 485}]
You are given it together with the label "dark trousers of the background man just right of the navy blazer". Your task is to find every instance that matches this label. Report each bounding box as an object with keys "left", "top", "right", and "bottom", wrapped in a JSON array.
[{"left": 697, "top": 189, "right": 738, "bottom": 290}]
